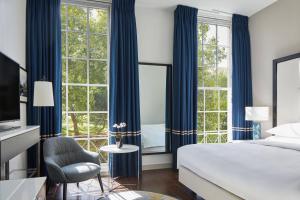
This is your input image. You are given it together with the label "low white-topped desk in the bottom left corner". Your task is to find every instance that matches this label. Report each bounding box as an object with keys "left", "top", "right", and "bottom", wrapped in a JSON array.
[{"left": 0, "top": 177, "right": 46, "bottom": 200}]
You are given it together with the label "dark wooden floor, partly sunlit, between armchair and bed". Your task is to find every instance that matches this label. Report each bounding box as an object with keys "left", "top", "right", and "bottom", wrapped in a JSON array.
[{"left": 47, "top": 169, "right": 197, "bottom": 200}]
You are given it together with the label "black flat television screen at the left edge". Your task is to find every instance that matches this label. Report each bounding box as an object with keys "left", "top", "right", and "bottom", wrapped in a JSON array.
[{"left": 0, "top": 52, "right": 20, "bottom": 121}]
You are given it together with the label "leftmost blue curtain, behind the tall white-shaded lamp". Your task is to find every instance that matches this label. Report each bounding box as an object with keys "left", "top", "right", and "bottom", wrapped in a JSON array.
[{"left": 26, "top": 0, "right": 61, "bottom": 173}]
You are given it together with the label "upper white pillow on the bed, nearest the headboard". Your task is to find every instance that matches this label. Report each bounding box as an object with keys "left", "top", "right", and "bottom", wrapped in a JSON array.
[{"left": 266, "top": 123, "right": 300, "bottom": 138}]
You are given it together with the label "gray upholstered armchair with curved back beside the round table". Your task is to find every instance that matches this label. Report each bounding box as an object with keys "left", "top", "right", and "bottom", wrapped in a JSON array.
[{"left": 43, "top": 137, "right": 104, "bottom": 200}]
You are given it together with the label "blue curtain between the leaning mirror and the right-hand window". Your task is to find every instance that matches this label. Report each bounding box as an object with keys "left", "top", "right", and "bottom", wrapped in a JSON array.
[{"left": 171, "top": 5, "right": 198, "bottom": 168}]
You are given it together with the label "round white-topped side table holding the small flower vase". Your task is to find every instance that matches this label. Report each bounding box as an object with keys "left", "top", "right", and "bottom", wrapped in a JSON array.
[{"left": 99, "top": 144, "right": 140, "bottom": 191}]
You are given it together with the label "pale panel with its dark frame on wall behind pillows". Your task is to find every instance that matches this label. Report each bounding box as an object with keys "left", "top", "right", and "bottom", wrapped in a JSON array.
[{"left": 273, "top": 54, "right": 300, "bottom": 126}]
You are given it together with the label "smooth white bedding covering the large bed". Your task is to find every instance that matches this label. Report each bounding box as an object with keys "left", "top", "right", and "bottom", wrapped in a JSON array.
[{"left": 177, "top": 141, "right": 300, "bottom": 200}]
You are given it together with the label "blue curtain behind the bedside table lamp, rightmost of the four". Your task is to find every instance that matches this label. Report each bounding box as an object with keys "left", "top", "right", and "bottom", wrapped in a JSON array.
[{"left": 232, "top": 15, "right": 252, "bottom": 140}]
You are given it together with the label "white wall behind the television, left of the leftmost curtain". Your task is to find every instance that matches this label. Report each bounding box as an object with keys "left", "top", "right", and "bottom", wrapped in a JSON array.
[{"left": 0, "top": 0, "right": 27, "bottom": 179}]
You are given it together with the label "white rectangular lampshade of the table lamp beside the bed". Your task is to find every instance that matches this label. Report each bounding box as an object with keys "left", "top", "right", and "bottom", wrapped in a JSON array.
[{"left": 245, "top": 107, "right": 269, "bottom": 122}]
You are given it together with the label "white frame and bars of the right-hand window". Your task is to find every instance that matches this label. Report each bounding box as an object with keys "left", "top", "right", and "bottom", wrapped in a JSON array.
[{"left": 197, "top": 14, "right": 232, "bottom": 143}]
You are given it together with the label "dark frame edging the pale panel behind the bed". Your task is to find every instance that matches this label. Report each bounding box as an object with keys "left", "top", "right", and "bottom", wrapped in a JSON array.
[{"left": 273, "top": 53, "right": 300, "bottom": 127}]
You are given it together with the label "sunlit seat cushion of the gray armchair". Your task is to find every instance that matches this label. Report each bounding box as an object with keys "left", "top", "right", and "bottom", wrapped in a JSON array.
[{"left": 62, "top": 162, "right": 100, "bottom": 183}]
